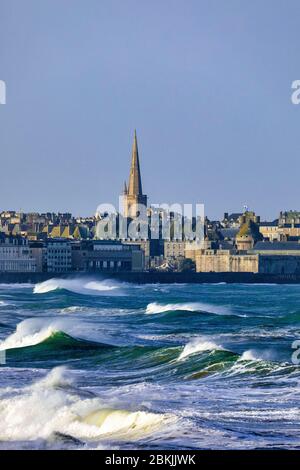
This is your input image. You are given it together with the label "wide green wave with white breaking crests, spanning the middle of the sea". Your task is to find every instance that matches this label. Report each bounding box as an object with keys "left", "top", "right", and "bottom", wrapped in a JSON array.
[{"left": 0, "top": 318, "right": 296, "bottom": 382}]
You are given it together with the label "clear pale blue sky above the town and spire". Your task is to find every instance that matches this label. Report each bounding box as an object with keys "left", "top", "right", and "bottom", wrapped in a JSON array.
[{"left": 0, "top": 0, "right": 300, "bottom": 219}]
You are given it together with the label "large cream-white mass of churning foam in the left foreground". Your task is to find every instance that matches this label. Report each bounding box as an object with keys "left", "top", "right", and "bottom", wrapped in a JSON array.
[{"left": 0, "top": 368, "right": 171, "bottom": 441}]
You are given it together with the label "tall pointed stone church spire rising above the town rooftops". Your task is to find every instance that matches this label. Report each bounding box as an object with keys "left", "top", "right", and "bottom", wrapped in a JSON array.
[{"left": 123, "top": 131, "right": 147, "bottom": 219}]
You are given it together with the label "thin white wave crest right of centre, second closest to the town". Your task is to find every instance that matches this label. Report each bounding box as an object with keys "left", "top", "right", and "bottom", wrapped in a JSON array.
[{"left": 146, "top": 302, "right": 232, "bottom": 315}]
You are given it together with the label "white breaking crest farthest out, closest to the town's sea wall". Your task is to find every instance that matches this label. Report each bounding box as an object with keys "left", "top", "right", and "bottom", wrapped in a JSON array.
[{"left": 33, "top": 278, "right": 120, "bottom": 294}]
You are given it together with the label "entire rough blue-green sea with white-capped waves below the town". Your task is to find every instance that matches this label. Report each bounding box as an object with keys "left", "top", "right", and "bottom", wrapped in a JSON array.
[{"left": 0, "top": 279, "right": 300, "bottom": 449}]
